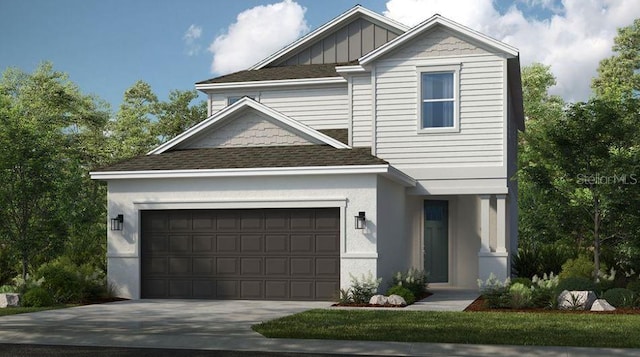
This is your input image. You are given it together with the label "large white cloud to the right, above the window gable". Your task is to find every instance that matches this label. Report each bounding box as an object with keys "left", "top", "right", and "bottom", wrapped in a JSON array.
[{"left": 384, "top": 0, "right": 640, "bottom": 101}]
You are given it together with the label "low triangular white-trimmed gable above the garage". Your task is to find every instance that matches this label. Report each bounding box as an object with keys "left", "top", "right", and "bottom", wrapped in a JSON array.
[{"left": 148, "top": 97, "right": 349, "bottom": 155}]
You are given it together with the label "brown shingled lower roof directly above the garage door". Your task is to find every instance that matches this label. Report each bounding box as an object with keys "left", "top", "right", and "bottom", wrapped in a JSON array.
[{"left": 96, "top": 145, "right": 388, "bottom": 172}]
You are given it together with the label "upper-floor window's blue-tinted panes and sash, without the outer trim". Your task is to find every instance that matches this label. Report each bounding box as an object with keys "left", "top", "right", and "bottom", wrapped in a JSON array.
[{"left": 422, "top": 72, "right": 456, "bottom": 128}]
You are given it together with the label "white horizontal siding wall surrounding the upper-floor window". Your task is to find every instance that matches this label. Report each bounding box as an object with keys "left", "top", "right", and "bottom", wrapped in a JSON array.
[{"left": 375, "top": 30, "right": 506, "bottom": 172}]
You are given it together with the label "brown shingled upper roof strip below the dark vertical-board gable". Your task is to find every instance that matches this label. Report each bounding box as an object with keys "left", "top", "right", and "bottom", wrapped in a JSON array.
[{"left": 196, "top": 63, "right": 353, "bottom": 85}]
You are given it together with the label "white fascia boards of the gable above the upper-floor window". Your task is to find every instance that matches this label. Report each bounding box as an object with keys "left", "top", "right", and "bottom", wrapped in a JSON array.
[{"left": 358, "top": 15, "right": 518, "bottom": 66}]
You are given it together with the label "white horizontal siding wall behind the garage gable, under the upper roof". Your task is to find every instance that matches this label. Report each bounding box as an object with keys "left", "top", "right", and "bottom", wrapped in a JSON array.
[{"left": 211, "top": 84, "right": 349, "bottom": 130}]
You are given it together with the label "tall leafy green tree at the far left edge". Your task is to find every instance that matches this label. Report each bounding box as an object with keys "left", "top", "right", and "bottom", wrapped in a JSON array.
[{"left": 0, "top": 63, "right": 106, "bottom": 277}]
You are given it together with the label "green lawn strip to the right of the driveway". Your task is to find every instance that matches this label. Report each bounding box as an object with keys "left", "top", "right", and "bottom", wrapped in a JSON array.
[{"left": 253, "top": 309, "right": 640, "bottom": 348}]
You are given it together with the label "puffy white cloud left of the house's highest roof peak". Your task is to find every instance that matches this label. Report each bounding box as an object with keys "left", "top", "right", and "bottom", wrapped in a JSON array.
[{"left": 209, "top": 0, "right": 309, "bottom": 74}]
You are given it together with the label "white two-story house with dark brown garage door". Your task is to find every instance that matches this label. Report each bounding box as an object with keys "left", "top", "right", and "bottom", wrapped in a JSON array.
[{"left": 91, "top": 6, "right": 524, "bottom": 300}]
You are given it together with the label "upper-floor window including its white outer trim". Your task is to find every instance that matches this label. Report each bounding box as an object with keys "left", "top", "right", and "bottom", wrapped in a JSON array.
[{"left": 419, "top": 66, "right": 459, "bottom": 132}]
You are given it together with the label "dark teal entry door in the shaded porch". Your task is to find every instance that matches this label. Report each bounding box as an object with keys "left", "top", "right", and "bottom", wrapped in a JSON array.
[{"left": 424, "top": 200, "right": 449, "bottom": 283}]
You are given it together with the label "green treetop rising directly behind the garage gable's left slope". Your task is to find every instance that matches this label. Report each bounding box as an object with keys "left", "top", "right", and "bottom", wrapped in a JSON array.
[{"left": 155, "top": 90, "right": 207, "bottom": 142}]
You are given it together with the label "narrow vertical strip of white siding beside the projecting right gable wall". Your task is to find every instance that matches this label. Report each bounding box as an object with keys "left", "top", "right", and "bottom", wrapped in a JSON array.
[{"left": 351, "top": 74, "right": 373, "bottom": 147}]
